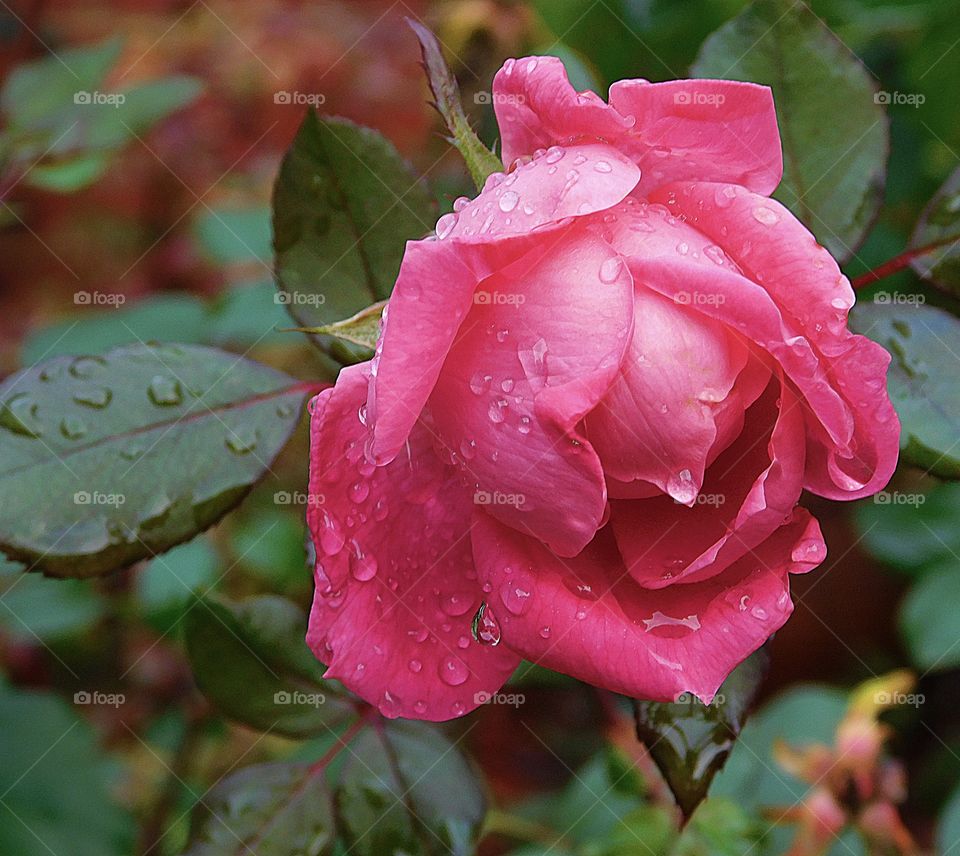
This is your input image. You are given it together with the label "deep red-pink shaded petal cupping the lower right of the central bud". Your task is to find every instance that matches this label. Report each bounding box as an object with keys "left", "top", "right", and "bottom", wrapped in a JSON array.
[{"left": 611, "top": 379, "right": 804, "bottom": 589}]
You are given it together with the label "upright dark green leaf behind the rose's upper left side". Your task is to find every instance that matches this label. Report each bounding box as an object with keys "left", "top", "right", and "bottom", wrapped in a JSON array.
[{"left": 273, "top": 111, "right": 435, "bottom": 348}]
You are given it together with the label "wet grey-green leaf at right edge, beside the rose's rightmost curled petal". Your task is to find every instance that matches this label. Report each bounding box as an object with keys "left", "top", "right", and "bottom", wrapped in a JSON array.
[{"left": 851, "top": 295, "right": 960, "bottom": 478}]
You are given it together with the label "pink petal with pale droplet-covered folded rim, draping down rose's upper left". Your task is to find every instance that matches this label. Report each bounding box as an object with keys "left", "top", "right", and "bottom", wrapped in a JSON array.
[{"left": 368, "top": 149, "right": 639, "bottom": 463}]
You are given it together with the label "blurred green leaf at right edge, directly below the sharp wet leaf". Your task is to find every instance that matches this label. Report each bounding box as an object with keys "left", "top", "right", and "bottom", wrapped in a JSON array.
[{"left": 854, "top": 484, "right": 960, "bottom": 576}]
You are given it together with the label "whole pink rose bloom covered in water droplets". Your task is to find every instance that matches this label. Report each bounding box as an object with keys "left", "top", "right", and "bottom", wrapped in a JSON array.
[{"left": 307, "top": 57, "right": 899, "bottom": 720}]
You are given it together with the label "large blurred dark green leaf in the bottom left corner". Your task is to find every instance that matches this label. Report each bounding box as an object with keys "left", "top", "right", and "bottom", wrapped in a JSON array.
[{"left": 0, "top": 684, "right": 133, "bottom": 856}]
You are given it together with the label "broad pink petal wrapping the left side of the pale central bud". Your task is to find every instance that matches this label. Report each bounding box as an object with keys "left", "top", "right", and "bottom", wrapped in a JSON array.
[{"left": 432, "top": 225, "right": 633, "bottom": 556}]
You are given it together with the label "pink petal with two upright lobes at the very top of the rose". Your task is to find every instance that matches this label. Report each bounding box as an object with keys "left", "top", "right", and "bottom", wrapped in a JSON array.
[{"left": 493, "top": 57, "right": 783, "bottom": 194}]
